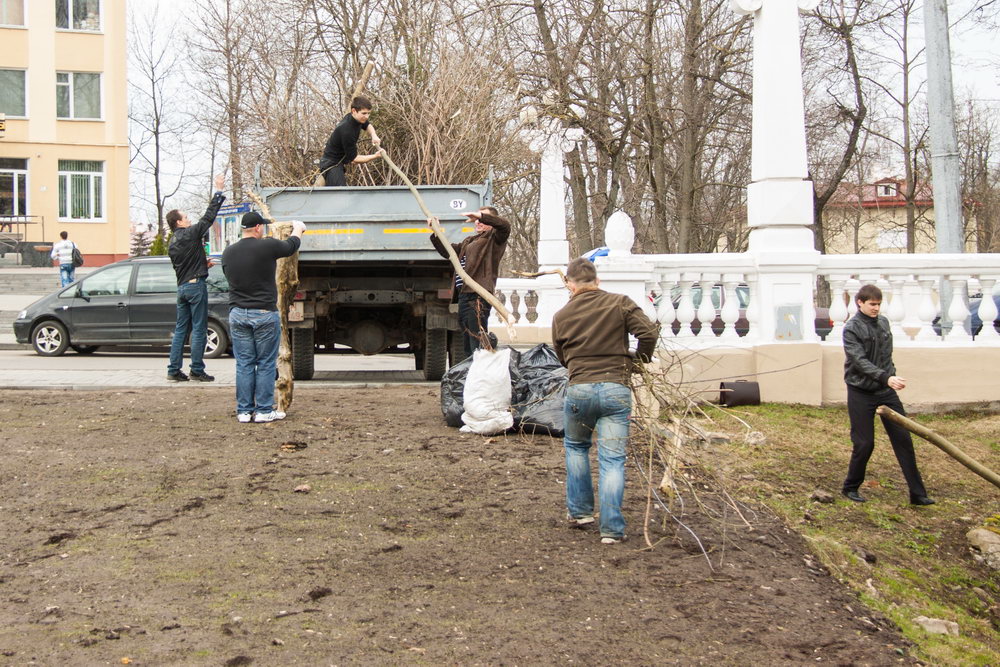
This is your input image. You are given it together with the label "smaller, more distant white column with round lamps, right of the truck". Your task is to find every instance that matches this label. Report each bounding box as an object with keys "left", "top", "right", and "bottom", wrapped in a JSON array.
[{"left": 529, "top": 118, "right": 583, "bottom": 271}]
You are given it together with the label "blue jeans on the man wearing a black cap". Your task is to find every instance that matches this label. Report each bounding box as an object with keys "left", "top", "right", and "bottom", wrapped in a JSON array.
[{"left": 229, "top": 307, "right": 281, "bottom": 414}]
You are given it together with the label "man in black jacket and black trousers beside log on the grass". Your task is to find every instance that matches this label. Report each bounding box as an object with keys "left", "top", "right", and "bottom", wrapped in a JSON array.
[{"left": 843, "top": 285, "right": 934, "bottom": 505}]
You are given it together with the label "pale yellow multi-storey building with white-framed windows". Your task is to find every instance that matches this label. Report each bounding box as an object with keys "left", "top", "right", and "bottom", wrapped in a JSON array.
[{"left": 0, "top": 0, "right": 130, "bottom": 266}]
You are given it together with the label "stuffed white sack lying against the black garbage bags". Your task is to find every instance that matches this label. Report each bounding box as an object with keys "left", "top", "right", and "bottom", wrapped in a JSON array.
[{"left": 460, "top": 347, "right": 514, "bottom": 435}]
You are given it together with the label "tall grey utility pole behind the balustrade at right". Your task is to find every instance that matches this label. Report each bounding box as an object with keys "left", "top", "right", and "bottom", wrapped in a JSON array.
[{"left": 924, "top": 0, "right": 968, "bottom": 331}]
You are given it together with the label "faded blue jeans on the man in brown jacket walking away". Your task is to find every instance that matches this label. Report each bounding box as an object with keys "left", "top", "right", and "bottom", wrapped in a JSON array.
[{"left": 563, "top": 382, "right": 632, "bottom": 537}]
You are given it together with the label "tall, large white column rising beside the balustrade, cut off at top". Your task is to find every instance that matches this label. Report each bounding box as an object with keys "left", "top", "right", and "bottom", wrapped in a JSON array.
[{"left": 730, "top": 0, "right": 819, "bottom": 343}]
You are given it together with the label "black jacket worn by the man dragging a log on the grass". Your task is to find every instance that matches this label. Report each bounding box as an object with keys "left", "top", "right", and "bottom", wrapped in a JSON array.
[{"left": 844, "top": 311, "right": 896, "bottom": 392}]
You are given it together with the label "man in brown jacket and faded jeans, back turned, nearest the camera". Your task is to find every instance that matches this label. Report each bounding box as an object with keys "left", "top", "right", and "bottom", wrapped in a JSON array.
[{"left": 552, "top": 257, "right": 659, "bottom": 544}]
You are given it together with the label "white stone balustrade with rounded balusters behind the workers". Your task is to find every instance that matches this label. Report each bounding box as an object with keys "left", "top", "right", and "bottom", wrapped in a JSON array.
[{"left": 492, "top": 231, "right": 1000, "bottom": 347}]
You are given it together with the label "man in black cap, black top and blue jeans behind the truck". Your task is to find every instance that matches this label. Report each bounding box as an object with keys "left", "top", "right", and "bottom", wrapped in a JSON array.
[{"left": 222, "top": 211, "right": 306, "bottom": 423}]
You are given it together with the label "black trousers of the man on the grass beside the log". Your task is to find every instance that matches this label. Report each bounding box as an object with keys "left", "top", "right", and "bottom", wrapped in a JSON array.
[{"left": 844, "top": 385, "right": 927, "bottom": 496}]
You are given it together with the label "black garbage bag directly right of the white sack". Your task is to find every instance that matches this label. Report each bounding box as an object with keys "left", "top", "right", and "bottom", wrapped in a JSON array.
[{"left": 511, "top": 343, "right": 569, "bottom": 437}]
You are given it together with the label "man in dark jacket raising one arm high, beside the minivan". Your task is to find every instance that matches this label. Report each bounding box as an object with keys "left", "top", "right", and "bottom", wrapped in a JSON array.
[{"left": 167, "top": 174, "right": 226, "bottom": 382}]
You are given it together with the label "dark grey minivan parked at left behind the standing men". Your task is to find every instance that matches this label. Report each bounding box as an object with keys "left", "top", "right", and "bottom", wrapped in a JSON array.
[{"left": 14, "top": 256, "right": 229, "bottom": 359}]
